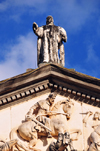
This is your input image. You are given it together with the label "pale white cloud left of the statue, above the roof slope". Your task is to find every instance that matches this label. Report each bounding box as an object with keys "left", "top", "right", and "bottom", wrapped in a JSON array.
[{"left": 0, "top": 33, "right": 37, "bottom": 80}]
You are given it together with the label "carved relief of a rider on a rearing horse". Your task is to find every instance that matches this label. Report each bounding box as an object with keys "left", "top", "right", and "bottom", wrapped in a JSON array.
[{"left": 11, "top": 93, "right": 81, "bottom": 151}]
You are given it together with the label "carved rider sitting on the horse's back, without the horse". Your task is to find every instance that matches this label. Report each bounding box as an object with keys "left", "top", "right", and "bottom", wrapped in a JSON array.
[{"left": 25, "top": 93, "right": 56, "bottom": 138}]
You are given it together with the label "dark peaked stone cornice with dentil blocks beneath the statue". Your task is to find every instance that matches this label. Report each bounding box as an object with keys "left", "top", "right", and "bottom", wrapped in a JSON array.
[{"left": 0, "top": 64, "right": 100, "bottom": 107}]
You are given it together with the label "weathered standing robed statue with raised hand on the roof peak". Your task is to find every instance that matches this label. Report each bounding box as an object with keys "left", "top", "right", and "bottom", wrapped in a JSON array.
[{"left": 33, "top": 16, "right": 67, "bottom": 66}]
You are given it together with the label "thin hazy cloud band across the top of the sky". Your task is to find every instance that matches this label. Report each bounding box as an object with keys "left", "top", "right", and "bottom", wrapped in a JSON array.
[{"left": 0, "top": 0, "right": 99, "bottom": 32}]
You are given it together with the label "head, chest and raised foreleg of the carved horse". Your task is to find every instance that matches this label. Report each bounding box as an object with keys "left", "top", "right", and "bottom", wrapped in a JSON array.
[{"left": 47, "top": 98, "right": 82, "bottom": 140}]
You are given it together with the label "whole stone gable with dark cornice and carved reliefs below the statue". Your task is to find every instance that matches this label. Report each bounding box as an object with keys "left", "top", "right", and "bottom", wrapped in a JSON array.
[{"left": 0, "top": 64, "right": 100, "bottom": 151}]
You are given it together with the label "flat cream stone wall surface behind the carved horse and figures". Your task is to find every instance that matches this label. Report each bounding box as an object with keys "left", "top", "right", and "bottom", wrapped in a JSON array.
[{"left": 0, "top": 93, "right": 100, "bottom": 151}]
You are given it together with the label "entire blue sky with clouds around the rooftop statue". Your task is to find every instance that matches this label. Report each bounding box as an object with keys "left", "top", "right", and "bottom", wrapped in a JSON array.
[{"left": 0, "top": 0, "right": 100, "bottom": 80}]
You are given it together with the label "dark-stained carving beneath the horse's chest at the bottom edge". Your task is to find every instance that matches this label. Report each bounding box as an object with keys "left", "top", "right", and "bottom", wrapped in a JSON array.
[{"left": 49, "top": 132, "right": 75, "bottom": 151}]
